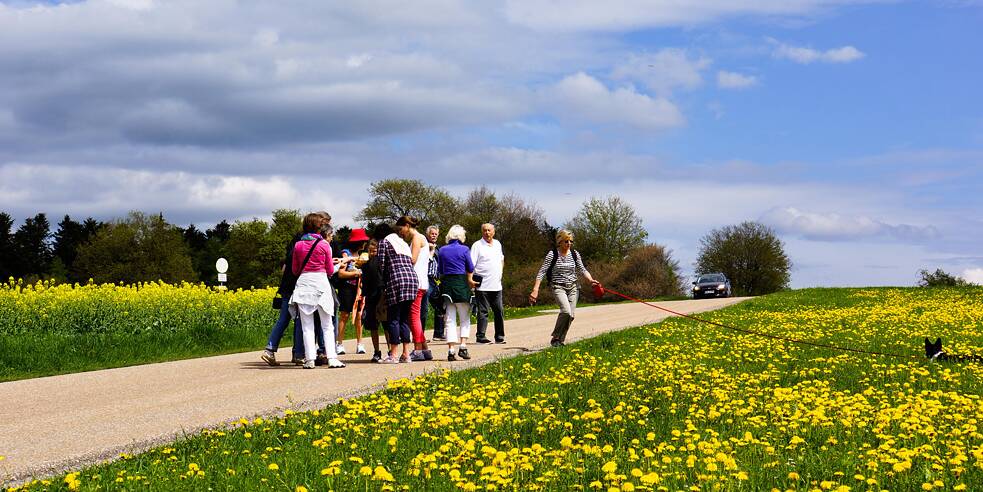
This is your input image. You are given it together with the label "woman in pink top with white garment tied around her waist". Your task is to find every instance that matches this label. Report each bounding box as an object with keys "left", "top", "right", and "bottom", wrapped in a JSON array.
[{"left": 290, "top": 213, "right": 345, "bottom": 369}]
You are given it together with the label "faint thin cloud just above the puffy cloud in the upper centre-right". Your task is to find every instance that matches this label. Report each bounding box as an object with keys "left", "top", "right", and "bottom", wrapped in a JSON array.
[{"left": 611, "top": 48, "right": 712, "bottom": 95}]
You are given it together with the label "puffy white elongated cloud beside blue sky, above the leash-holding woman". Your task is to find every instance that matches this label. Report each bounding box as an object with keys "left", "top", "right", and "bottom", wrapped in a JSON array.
[{"left": 544, "top": 72, "right": 685, "bottom": 130}]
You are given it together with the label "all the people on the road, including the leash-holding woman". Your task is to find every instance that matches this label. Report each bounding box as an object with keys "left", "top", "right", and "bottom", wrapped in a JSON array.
[{"left": 261, "top": 212, "right": 597, "bottom": 369}]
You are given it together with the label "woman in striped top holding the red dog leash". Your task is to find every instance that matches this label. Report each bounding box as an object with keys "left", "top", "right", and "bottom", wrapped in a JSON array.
[{"left": 529, "top": 229, "right": 598, "bottom": 347}]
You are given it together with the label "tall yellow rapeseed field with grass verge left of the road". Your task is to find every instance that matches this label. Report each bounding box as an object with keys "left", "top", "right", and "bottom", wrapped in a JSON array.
[{"left": 0, "top": 280, "right": 553, "bottom": 382}]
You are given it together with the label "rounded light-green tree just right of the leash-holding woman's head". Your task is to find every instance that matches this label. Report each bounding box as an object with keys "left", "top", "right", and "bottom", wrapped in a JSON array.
[{"left": 565, "top": 195, "right": 648, "bottom": 259}]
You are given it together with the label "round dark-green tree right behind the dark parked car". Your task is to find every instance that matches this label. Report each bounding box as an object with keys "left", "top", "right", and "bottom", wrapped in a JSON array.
[{"left": 696, "top": 222, "right": 792, "bottom": 296}]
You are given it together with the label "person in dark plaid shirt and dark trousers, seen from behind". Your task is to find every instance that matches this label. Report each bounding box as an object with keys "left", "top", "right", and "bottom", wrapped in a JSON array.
[{"left": 377, "top": 218, "right": 420, "bottom": 364}]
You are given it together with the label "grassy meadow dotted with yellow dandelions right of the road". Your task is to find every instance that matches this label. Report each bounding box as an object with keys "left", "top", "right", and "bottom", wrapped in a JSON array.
[{"left": 7, "top": 288, "right": 983, "bottom": 492}]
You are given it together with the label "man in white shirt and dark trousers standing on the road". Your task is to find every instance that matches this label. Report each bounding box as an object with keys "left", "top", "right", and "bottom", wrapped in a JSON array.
[{"left": 471, "top": 224, "right": 505, "bottom": 343}]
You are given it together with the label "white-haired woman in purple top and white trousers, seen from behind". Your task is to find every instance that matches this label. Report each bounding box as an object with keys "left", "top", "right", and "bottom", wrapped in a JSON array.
[{"left": 437, "top": 225, "right": 475, "bottom": 361}]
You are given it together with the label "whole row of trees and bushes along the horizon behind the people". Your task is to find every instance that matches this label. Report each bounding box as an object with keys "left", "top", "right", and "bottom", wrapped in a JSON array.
[{"left": 0, "top": 179, "right": 790, "bottom": 305}]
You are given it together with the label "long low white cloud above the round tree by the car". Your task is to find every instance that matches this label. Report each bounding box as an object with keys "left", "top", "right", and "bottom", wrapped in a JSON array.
[{"left": 761, "top": 207, "right": 939, "bottom": 242}]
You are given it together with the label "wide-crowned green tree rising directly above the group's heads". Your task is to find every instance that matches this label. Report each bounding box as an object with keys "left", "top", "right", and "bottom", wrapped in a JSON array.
[{"left": 356, "top": 179, "right": 460, "bottom": 228}]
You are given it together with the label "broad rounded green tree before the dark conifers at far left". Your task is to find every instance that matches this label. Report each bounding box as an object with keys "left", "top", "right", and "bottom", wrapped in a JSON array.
[{"left": 73, "top": 212, "right": 197, "bottom": 283}]
